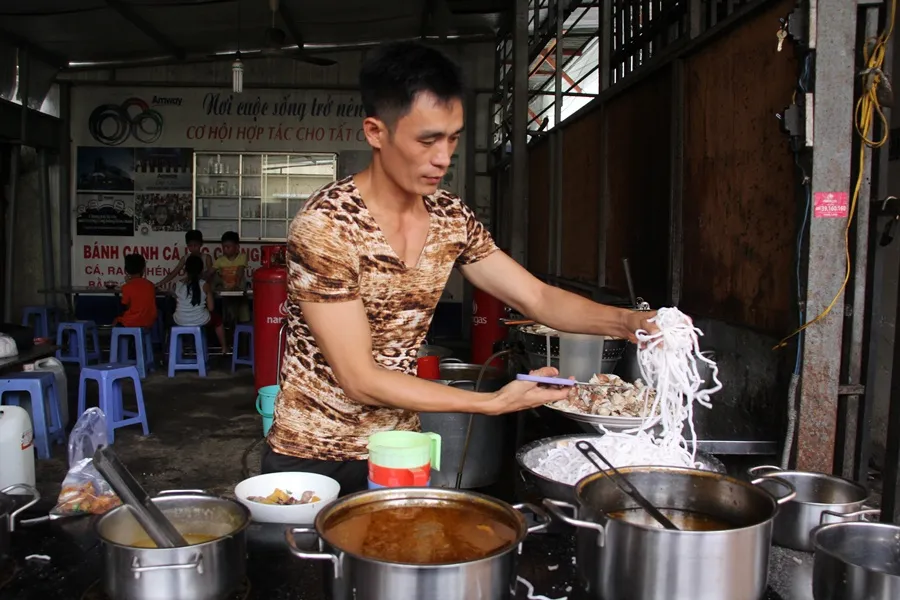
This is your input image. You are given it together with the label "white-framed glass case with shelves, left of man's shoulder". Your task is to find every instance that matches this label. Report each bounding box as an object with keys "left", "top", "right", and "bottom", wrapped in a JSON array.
[{"left": 194, "top": 152, "right": 337, "bottom": 242}]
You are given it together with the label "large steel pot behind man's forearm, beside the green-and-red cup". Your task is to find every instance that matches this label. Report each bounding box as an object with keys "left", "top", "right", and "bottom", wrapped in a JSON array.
[{"left": 419, "top": 360, "right": 513, "bottom": 488}]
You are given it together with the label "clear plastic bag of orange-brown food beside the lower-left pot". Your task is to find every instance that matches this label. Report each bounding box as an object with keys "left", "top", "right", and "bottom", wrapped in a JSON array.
[{"left": 50, "top": 408, "right": 122, "bottom": 516}]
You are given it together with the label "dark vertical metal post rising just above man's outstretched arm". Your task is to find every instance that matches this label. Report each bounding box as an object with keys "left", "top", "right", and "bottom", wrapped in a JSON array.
[{"left": 509, "top": 0, "right": 528, "bottom": 265}]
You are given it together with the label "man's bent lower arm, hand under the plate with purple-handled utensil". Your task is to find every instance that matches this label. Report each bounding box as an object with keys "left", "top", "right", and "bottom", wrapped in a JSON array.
[{"left": 300, "top": 300, "right": 568, "bottom": 415}]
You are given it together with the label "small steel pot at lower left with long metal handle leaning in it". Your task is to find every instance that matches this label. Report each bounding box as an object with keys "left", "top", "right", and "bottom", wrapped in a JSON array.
[{"left": 96, "top": 490, "right": 250, "bottom": 600}]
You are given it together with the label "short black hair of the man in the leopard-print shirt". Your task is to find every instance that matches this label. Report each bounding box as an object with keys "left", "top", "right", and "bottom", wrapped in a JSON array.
[{"left": 359, "top": 42, "right": 465, "bottom": 125}]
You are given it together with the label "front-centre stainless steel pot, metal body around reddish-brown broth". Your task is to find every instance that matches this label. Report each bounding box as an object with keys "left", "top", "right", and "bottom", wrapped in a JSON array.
[{"left": 286, "top": 488, "right": 549, "bottom": 600}]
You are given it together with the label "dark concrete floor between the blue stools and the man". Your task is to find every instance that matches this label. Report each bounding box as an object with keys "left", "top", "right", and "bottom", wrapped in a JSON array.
[{"left": 37, "top": 357, "right": 262, "bottom": 506}]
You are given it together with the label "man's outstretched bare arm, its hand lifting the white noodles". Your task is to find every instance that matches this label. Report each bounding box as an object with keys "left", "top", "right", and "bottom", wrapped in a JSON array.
[{"left": 460, "top": 250, "right": 655, "bottom": 342}]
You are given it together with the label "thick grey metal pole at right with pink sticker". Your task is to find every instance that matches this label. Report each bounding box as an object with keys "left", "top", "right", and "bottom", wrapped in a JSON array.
[{"left": 797, "top": 0, "right": 866, "bottom": 473}]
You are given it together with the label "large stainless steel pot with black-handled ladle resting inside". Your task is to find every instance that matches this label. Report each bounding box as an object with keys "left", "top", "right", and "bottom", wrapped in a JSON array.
[{"left": 544, "top": 467, "right": 794, "bottom": 600}]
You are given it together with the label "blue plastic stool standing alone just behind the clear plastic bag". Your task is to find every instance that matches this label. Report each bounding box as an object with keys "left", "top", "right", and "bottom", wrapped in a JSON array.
[{"left": 78, "top": 363, "right": 150, "bottom": 444}]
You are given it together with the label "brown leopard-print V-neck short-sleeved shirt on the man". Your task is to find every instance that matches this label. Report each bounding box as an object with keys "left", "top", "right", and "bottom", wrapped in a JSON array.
[{"left": 268, "top": 178, "right": 497, "bottom": 461}]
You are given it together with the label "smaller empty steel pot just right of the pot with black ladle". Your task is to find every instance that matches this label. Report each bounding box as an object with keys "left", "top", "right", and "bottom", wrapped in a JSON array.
[{"left": 747, "top": 465, "right": 878, "bottom": 552}]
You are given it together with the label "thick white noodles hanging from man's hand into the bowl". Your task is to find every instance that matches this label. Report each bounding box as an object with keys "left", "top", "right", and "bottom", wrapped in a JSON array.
[{"left": 597, "top": 308, "right": 722, "bottom": 467}]
